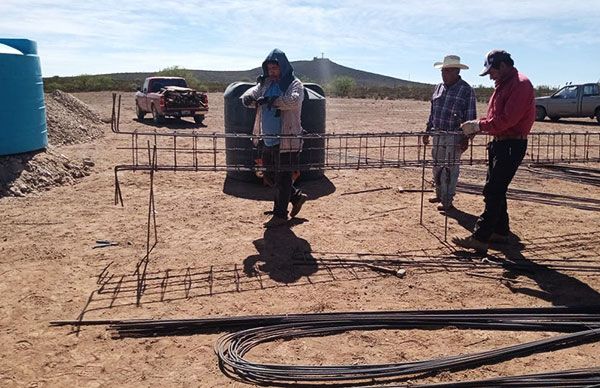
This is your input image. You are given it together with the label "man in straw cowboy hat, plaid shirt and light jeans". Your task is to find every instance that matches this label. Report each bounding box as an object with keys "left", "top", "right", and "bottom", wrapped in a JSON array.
[{"left": 423, "top": 55, "right": 477, "bottom": 211}]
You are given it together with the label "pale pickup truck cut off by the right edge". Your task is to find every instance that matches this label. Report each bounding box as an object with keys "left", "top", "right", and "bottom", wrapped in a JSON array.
[{"left": 535, "top": 84, "right": 600, "bottom": 123}]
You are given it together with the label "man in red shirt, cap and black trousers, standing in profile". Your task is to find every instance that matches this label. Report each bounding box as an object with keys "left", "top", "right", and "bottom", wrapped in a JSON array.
[{"left": 452, "top": 50, "right": 535, "bottom": 252}]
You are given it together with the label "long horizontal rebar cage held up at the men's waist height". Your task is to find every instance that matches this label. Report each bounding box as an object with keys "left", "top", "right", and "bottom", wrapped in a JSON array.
[{"left": 112, "top": 94, "right": 600, "bottom": 185}]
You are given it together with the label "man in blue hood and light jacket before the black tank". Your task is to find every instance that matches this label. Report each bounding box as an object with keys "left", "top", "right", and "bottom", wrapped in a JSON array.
[{"left": 241, "top": 49, "right": 307, "bottom": 228}]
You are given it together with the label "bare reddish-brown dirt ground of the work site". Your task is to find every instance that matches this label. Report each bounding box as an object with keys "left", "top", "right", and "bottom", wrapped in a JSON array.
[{"left": 0, "top": 93, "right": 600, "bottom": 387}]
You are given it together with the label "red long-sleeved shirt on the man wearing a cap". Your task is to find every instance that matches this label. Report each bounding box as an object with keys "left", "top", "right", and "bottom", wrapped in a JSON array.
[{"left": 479, "top": 68, "right": 535, "bottom": 137}]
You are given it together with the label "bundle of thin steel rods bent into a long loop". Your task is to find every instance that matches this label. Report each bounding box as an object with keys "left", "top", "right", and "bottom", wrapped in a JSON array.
[{"left": 215, "top": 319, "right": 600, "bottom": 384}]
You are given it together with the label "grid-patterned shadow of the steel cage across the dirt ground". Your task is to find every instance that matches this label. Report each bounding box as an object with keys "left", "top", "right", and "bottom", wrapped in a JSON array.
[{"left": 70, "top": 231, "right": 600, "bottom": 322}]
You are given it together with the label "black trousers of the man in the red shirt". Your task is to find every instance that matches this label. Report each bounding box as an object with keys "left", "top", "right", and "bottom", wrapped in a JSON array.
[{"left": 473, "top": 139, "right": 527, "bottom": 242}]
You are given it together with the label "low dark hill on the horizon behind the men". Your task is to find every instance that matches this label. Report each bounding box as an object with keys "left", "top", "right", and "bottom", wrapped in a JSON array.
[{"left": 108, "top": 57, "right": 430, "bottom": 87}]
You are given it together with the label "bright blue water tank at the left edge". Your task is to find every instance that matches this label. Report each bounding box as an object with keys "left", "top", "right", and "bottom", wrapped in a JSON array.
[{"left": 0, "top": 38, "right": 48, "bottom": 155}]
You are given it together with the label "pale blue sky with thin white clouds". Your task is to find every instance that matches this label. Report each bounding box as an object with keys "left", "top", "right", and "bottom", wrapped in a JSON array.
[{"left": 0, "top": 0, "right": 600, "bottom": 86}]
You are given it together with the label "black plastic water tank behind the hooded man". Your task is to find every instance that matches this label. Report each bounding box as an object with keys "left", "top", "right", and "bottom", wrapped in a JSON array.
[{"left": 223, "top": 82, "right": 325, "bottom": 182}]
